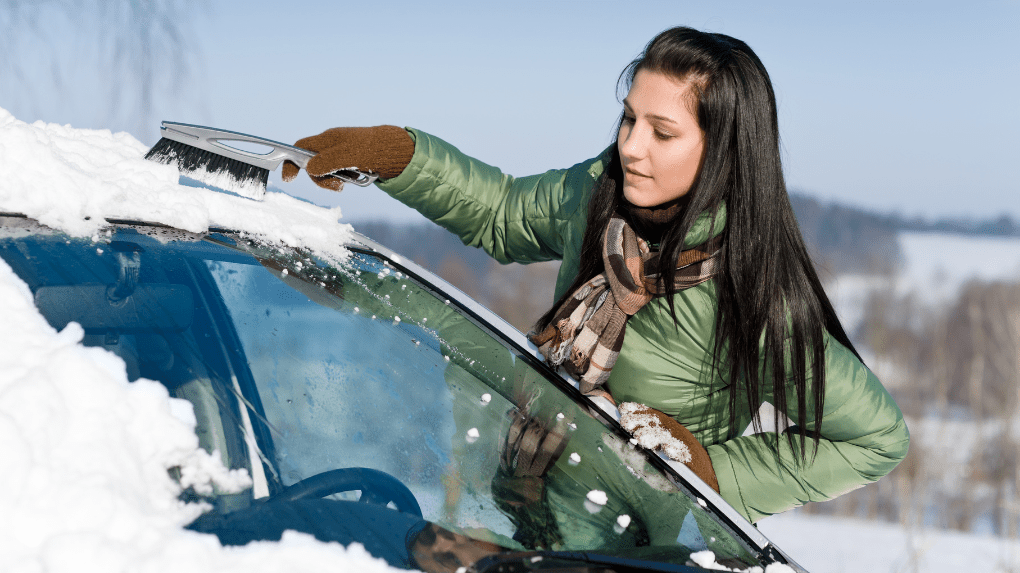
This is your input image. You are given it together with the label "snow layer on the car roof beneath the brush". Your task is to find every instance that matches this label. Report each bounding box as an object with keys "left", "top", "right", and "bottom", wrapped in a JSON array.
[{"left": 0, "top": 108, "right": 351, "bottom": 261}]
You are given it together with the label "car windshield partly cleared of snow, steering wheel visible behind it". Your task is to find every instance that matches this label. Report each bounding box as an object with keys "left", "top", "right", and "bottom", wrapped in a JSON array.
[{"left": 0, "top": 217, "right": 759, "bottom": 571}]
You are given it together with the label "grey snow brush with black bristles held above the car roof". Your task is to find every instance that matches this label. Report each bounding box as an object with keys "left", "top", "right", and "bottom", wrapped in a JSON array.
[{"left": 145, "top": 121, "right": 378, "bottom": 201}]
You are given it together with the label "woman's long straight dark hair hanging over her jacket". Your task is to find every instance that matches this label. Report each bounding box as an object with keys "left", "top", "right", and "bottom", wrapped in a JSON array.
[{"left": 539, "top": 28, "right": 860, "bottom": 460}]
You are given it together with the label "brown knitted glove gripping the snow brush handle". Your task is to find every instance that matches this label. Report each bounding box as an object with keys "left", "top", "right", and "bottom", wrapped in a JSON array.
[{"left": 284, "top": 125, "right": 414, "bottom": 191}]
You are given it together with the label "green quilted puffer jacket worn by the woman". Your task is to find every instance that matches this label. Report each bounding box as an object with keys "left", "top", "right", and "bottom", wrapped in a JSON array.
[{"left": 377, "top": 128, "right": 909, "bottom": 522}]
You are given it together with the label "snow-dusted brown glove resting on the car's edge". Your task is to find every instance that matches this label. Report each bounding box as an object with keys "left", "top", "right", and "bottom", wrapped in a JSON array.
[{"left": 620, "top": 402, "right": 719, "bottom": 492}]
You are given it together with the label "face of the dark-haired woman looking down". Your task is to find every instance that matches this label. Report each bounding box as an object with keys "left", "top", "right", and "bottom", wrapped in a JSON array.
[{"left": 616, "top": 69, "right": 705, "bottom": 207}]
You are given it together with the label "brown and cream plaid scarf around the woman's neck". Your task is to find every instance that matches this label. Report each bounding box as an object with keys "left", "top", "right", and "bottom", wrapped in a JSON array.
[{"left": 529, "top": 216, "right": 722, "bottom": 394}]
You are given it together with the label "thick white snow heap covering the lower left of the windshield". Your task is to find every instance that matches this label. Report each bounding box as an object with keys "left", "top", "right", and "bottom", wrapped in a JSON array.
[{"left": 0, "top": 260, "right": 399, "bottom": 572}]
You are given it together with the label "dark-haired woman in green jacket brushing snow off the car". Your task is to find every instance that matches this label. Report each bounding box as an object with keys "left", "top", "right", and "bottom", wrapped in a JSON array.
[{"left": 285, "top": 28, "right": 909, "bottom": 521}]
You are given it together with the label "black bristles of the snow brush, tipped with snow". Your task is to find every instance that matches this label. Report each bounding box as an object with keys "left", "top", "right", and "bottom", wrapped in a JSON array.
[{"left": 145, "top": 138, "right": 269, "bottom": 199}]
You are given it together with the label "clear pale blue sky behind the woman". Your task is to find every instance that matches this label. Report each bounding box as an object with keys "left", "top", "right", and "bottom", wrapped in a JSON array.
[{"left": 0, "top": 0, "right": 1020, "bottom": 220}]
